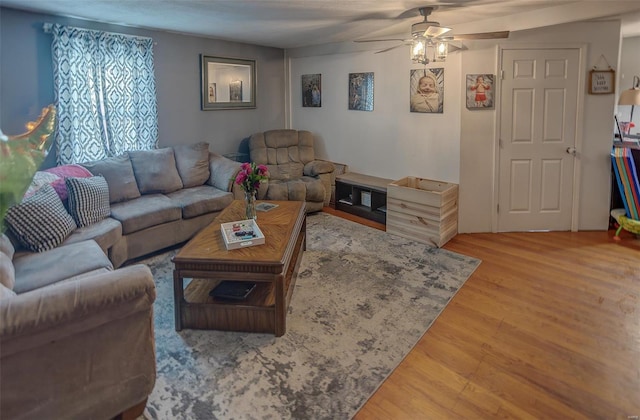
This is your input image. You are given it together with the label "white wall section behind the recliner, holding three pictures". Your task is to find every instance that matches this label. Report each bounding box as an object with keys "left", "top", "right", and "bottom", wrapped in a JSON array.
[{"left": 290, "top": 47, "right": 464, "bottom": 183}]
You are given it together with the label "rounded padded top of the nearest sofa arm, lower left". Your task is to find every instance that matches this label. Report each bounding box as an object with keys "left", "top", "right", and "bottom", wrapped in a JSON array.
[{"left": 0, "top": 264, "right": 156, "bottom": 358}]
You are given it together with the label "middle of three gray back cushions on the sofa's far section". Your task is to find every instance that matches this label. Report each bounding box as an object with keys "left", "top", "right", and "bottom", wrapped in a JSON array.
[{"left": 129, "top": 147, "right": 182, "bottom": 194}]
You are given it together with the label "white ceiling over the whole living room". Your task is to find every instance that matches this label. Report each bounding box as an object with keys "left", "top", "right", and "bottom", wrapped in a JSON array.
[{"left": 0, "top": 0, "right": 640, "bottom": 49}]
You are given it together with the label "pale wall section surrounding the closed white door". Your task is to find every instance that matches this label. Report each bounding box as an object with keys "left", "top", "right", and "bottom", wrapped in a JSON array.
[{"left": 459, "top": 21, "right": 620, "bottom": 232}]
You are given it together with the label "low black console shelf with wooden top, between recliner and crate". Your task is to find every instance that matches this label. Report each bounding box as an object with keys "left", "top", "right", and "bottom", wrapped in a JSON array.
[{"left": 335, "top": 172, "right": 393, "bottom": 223}]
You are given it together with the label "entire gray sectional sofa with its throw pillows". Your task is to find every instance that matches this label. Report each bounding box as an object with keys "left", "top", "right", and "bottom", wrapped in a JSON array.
[{"left": 0, "top": 143, "right": 243, "bottom": 418}]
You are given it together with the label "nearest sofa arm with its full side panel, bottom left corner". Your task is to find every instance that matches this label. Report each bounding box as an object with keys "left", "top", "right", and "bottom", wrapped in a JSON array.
[{"left": 0, "top": 265, "right": 156, "bottom": 419}]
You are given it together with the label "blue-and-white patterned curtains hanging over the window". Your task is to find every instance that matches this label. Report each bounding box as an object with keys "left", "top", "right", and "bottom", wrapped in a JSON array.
[{"left": 51, "top": 24, "right": 158, "bottom": 165}]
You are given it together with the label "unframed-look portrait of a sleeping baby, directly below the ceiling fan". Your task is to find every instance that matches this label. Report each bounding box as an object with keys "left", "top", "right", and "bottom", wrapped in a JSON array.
[{"left": 409, "top": 68, "right": 444, "bottom": 114}]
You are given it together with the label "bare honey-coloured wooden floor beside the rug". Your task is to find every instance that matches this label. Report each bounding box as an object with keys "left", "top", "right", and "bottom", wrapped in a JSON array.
[{"left": 324, "top": 208, "right": 640, "bottom": 420}]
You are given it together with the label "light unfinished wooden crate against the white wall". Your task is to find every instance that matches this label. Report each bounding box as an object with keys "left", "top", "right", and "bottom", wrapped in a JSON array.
[{"left": 387, "top": 176, "right": 458, "bottom": 247}]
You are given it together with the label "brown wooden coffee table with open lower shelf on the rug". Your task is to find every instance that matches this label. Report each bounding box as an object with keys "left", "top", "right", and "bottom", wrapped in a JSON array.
[{"left": 173, "top": 200, "right": 306, "bottom": 337}]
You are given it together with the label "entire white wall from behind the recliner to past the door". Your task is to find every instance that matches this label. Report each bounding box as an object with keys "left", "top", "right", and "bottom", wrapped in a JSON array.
[{"left": 289, "top": 21, "right": 624, "bottom": 232}]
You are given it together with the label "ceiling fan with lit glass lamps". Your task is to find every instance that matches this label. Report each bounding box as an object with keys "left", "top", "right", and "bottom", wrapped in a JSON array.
[{"left": 355, "top": 6, "right": 509, "bottom": 64}]
